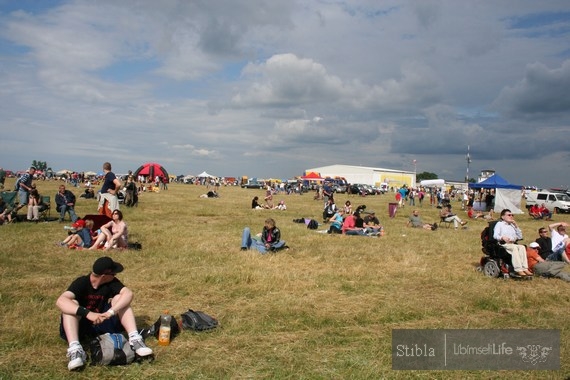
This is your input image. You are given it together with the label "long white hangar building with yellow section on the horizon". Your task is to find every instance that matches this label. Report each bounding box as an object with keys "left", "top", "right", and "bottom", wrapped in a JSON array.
[{"left": 305, "top": 165, "right": 416, "bottom": 187}]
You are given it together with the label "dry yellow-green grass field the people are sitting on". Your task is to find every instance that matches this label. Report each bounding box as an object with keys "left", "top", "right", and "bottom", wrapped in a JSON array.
[{"left": 0, "top": 180, "right": 570, "bottom": 379}]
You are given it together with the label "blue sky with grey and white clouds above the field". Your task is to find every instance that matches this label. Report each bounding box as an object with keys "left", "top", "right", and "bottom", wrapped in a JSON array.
[{"left": 0, "top": 0, "right": 570, "bottom": 186}]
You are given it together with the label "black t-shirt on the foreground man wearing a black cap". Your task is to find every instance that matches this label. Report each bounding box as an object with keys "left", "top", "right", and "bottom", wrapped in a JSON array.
[{"left": 67, "top": 275, "right": 125, "bottom": 313}]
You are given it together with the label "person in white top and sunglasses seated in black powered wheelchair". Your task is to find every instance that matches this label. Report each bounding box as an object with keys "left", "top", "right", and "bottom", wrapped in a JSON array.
[{"left": 493, "top": 209, "right": 533, "bottom": 277}]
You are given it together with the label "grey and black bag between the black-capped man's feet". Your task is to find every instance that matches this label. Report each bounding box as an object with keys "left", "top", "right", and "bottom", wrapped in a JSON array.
[{"left": 89, "top": 333, "right": 135, "bottom": 365}]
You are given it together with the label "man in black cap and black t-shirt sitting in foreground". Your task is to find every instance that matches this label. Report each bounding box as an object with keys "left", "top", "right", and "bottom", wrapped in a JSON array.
[{"left": 56, "top": 257, "right": 152, "bottom": 371}]
